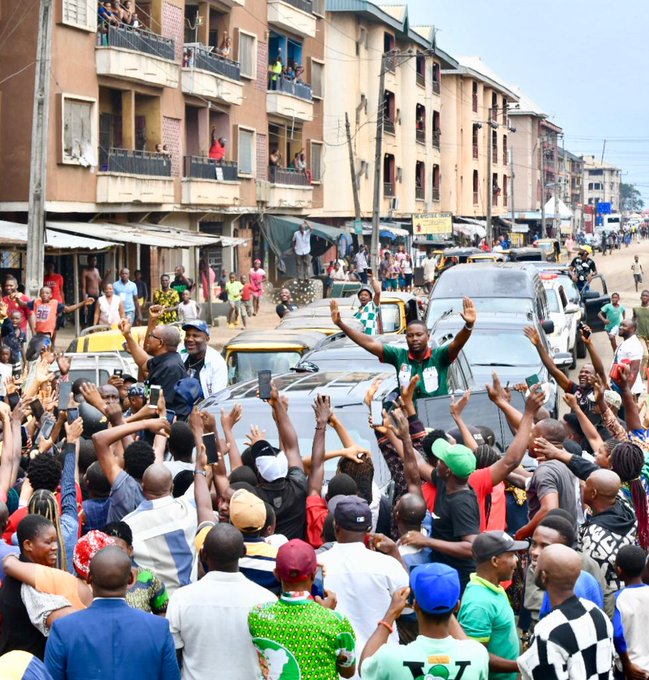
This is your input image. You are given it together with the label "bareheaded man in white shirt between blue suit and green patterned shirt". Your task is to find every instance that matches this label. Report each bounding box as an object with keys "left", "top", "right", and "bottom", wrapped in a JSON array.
[{"left": 167, "top": 524, "right": 277, "bottom": 680}]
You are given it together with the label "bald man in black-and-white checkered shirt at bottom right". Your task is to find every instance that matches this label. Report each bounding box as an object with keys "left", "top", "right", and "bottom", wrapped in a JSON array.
[{"left": 518, "top": 543, "right": 613, "bottom": 680}]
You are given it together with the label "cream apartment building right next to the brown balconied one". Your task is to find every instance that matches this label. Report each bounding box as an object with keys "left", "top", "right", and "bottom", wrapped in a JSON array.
[{"left": 322, "top": 0, "right": 456, "bottom": 224}]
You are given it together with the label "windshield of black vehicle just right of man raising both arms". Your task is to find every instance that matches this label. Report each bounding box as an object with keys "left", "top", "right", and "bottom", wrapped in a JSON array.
[{"left": 464, "top": 329, "right": 539, "bottom": 366}]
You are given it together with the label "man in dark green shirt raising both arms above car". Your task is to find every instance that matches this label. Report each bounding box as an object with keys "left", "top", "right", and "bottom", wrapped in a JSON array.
[{"left": 330, "top": 297, "right": 476, "bottom": 399}]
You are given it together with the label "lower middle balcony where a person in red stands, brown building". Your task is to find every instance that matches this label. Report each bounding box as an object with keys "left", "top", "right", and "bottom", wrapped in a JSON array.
[{"left": 182, "top": 156, "right": 240, "bottom": 206}]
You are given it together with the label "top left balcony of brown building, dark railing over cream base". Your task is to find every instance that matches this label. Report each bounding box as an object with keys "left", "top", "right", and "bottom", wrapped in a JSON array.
[{"left": 95, "top": 26, "right": 180, "bottom": 88}]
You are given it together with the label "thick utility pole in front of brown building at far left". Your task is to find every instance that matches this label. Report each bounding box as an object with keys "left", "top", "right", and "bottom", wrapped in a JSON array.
[{"left": 26, "top": 0, "right": 53, "bottom": 297}]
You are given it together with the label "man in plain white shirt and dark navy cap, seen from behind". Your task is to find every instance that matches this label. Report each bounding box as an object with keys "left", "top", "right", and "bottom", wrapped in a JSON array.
[{"left": 318, "top": 496, "right": 408, "bottom": 677}]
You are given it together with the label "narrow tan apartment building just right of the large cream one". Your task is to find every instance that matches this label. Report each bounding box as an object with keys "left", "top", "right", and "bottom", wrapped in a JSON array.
[{"left": 441, "top": 57, "right": 518, "bottom": 218}]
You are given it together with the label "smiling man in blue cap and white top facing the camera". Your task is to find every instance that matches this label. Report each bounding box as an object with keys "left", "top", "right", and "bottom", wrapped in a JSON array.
[{"left": 180, "top": 319, "right": 228, "bottom": 398}]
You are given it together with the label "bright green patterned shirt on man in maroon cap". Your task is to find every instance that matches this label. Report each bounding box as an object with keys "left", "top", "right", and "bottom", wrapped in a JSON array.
[{"left": 248, "top": 593, "right": 356, "bottom": 680}]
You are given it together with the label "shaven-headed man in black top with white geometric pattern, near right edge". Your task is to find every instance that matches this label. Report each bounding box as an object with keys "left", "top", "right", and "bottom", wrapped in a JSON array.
[{"left": 579, "top": 470, "right": 637, "bottom": 612}]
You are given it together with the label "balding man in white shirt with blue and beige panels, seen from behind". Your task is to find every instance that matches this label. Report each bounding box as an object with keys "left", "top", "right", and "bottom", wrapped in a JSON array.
[{"left": 124, "top": 463, "right": 197, "bottom": 595}]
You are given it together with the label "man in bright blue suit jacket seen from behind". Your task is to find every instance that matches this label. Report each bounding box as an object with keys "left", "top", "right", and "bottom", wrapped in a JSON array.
[{"left": 45, "top": 546, "right": 180, "bottom": 680}]
